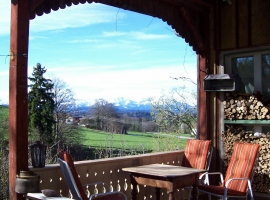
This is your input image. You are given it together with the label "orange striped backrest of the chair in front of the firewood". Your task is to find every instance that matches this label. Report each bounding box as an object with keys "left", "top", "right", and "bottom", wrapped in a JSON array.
[{"left": 223, "top": 142, "right": 260, "bottom": 192}]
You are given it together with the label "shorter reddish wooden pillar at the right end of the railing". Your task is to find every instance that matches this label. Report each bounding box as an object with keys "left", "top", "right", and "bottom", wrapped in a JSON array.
[{"left": 197, "top": 55, "right": 210, "bottom": 140}]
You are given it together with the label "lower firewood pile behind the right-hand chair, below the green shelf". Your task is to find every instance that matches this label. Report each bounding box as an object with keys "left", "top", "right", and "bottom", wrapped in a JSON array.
[{"left": 222, "top": 126, "right": 270, "bottom": 193}]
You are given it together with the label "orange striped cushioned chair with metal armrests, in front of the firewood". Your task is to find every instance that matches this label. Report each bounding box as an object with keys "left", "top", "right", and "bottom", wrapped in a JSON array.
[{"left": 198, "top": 142, "right": 260, "bottom": 200}]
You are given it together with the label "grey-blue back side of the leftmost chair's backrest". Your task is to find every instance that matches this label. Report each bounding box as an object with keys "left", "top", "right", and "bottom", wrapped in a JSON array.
[{"left": 58, "top": 158, "right": 82, "bottom": 200}]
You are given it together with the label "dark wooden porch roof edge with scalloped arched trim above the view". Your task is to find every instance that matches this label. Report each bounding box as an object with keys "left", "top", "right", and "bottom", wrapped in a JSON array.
[{"left": 30, "top": 0, "right": 213, "bottom": 56}]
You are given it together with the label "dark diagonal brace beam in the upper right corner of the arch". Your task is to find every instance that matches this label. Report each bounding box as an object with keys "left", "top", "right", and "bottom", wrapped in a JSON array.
[{"left": 180, "top": 7, "right": 206, "bottom": 52}]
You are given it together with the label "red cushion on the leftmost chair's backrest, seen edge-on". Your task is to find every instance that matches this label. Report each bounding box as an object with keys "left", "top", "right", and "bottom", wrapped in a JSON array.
[{"left": 58, "top": 151, "right": 88, "bottom": 200}]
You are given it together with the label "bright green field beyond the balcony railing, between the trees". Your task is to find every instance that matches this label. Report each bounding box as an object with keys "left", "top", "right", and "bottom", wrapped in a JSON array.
[{"left": 81, "top": 128, "right": 191, "bottom": 151}]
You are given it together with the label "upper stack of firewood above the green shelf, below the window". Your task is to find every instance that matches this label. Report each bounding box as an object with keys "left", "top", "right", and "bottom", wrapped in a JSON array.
[{"left": 223, "top": 92, "right": 270, "bottom": 120}]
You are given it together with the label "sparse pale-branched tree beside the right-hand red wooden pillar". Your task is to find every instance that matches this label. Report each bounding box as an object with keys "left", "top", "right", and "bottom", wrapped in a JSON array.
[{"left": 150, "top": 86, "right": 197, "bottom": 136}]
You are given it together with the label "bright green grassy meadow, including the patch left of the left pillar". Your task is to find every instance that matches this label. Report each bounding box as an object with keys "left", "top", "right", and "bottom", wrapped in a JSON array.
[{"left": 0, "top": 106, "right": 190, "bottom": 151}]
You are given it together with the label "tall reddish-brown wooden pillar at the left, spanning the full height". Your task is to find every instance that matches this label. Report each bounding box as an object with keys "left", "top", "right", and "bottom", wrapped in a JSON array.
[{"left": 9, "top": 0, "right": 30, "bottom": 200}]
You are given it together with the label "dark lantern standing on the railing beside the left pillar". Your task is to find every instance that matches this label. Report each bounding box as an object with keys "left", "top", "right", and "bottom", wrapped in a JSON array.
[{"left": 29, "top": 141, "right": 46, "bottom": 168}]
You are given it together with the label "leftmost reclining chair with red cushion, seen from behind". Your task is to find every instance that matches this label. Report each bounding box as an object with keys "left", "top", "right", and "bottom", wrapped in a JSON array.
[{"left": 58, "top": 151, "right": 127, "bottom": 200}]
